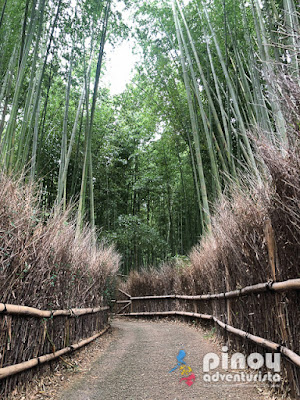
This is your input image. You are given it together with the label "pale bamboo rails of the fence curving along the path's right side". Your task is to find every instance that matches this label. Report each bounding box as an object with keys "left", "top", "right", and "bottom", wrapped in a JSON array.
[{"left": 116, "top": 279, "right": 300, "bottom": 398}]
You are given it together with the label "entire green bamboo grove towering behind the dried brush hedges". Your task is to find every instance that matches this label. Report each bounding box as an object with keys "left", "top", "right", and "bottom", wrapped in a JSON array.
[{"left": 0, "top": 0, "right": 300, "bottom": 272}]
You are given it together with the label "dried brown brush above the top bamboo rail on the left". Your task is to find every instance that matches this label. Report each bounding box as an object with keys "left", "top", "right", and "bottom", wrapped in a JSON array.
[{"left": 0, "top": 174, "right": 120, "bottom": 309}]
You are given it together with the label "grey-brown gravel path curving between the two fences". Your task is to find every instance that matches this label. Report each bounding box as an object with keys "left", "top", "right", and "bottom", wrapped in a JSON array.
[{"left": 58, "top": 320, "right": 268, "bottom": 400}]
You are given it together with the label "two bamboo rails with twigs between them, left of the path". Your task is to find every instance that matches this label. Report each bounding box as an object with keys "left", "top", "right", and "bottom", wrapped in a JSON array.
[{"left": 0, "top": 303, "right": 110, "bottom": 388}]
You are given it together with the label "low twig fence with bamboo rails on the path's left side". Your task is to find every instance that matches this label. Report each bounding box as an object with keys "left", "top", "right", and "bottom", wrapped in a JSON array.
[{"left": 0, "top": 303, "right": 109, "bottom": 398}]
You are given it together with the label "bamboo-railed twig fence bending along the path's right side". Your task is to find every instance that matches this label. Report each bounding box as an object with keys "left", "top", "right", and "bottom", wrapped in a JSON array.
[{"left": 119, "top": 279, "right": 300, "bottom": 399}]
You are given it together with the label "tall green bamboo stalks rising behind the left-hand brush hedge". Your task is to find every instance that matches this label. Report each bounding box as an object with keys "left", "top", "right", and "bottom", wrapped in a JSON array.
[{"left": 0, "top": 0, "right": 111, "bottom": 227}]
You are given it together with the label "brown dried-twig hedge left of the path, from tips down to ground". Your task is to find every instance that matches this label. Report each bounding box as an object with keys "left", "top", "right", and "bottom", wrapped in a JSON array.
[{"left": 0, "top": 174, "right": 120, "bottom": 398}]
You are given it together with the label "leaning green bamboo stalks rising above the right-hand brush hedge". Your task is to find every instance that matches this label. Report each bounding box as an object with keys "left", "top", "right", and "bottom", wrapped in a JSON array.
[{"left": 172, "top": 0, "right": 299, "bottom": 229}]
